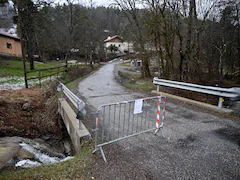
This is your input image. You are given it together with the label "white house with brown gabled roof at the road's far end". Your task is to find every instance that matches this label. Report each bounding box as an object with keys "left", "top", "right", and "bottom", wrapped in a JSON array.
[{"left": 104, "top": 35, "right": 134, "bottom": 54}]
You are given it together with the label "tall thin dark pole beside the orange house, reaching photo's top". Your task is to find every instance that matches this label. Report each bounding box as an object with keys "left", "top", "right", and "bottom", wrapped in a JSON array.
[{"left": 17, "top": 0, "right": 28, "bottom": 88}]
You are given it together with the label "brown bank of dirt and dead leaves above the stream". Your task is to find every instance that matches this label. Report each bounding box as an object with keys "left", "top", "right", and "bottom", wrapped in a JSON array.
[{"left": 0, "top": 87, "right": 62, "bottom": 139}]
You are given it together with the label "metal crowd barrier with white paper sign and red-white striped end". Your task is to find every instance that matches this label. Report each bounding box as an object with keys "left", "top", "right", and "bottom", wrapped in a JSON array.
[{"left": 93, "top": 96, "right": 166, "bottom": 162}]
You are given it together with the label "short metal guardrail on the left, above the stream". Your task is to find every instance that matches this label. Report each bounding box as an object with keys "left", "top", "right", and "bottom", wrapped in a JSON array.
[{"left": 57, "top": 82, "right": 86, "bottom": 129}]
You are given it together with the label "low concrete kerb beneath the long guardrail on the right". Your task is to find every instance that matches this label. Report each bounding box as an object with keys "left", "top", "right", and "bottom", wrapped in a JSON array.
[{"left": 151, "top": 90, "right": 233, "bottom": 113}]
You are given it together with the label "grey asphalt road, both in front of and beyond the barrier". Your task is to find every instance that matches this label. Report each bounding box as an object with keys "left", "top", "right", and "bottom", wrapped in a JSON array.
[{"left": 79, "top": 61, "right": 240, "bottom": 179}]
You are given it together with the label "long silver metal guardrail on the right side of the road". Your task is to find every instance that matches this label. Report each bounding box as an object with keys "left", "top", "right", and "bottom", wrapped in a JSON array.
[{"left": 153, "top": 77, "right": 240, "bottom": 108}]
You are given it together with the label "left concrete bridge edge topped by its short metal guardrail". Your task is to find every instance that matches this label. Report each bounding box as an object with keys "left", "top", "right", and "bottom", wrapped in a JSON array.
[{"left": 58, "top": 83, "right": 91, "bottom": 153}]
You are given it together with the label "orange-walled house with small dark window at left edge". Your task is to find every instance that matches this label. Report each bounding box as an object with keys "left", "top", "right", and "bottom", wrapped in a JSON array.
[{"left": 0, "top": 31, "right": 22, "bottom": 56}]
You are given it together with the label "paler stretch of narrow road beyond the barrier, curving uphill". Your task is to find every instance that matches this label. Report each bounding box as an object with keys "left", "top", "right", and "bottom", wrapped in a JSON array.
[{"left": 78, "top": 63, "right": 141, "bottom": 108}]
